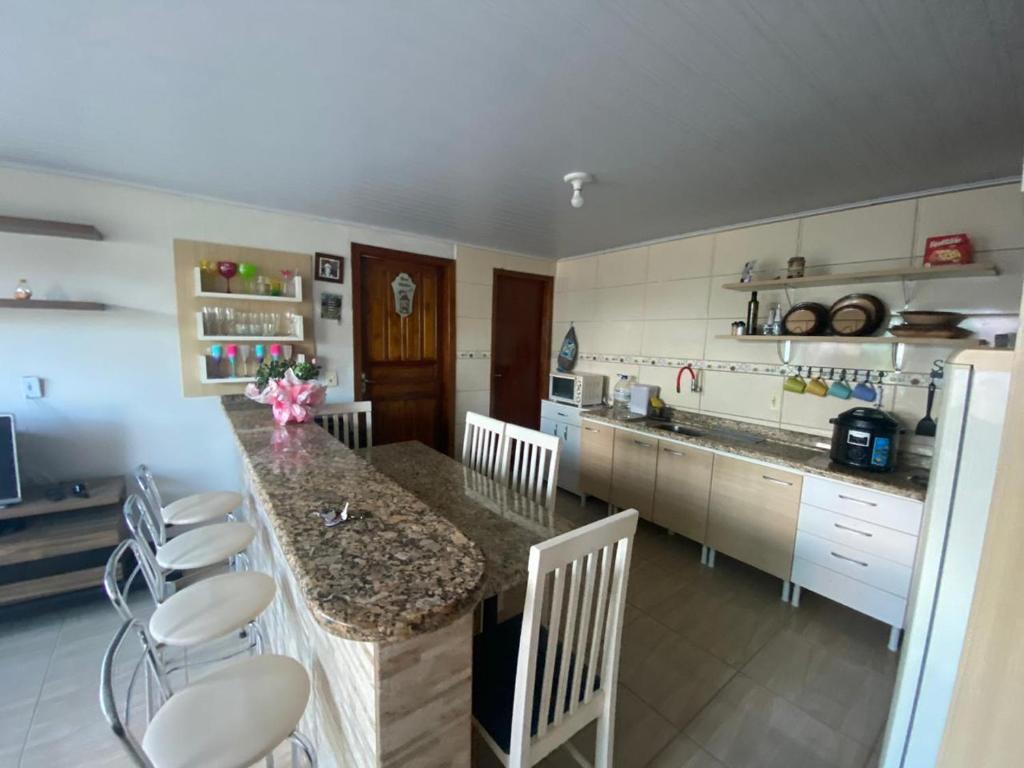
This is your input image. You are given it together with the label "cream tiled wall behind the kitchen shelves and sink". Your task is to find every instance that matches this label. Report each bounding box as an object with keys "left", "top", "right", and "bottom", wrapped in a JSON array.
[{"left": 552, "top": 184, "right": 1024, "bottom": 442}]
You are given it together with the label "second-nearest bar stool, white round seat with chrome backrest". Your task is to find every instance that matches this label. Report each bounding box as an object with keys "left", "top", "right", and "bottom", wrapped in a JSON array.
[{"left": 103, "top": 539, "right": 278, "bottom": 653}]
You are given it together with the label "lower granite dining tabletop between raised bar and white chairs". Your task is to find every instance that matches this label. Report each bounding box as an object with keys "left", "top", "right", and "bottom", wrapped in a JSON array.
[{"left": 366, "top": 442, "right": 592, "bottom": 597}]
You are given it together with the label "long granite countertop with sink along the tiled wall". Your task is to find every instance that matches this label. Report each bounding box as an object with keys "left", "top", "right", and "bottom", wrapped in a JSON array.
[{"left": 582, "top": 409, "right": 928, "bottom": 501}]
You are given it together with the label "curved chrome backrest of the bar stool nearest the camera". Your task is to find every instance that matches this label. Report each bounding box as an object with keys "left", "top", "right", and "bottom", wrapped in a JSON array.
[{"left": 99, "top": 618, "right": 171, "bottom": 768}]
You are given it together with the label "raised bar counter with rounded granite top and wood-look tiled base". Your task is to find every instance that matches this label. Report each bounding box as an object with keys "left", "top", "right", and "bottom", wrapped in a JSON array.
[{"left": 224, "top": 401, "right": 486, "bottom": 768}]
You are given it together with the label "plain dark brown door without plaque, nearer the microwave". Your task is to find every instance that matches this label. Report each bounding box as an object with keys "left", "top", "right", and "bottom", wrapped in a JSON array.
[{"left": 490, "top": 269, "right": 553, "bottom": 429}]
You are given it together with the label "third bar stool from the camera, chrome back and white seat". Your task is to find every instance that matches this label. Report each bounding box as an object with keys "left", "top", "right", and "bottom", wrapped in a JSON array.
[{"left": 124, "top": 494, "right": 256, "bottom": 594}]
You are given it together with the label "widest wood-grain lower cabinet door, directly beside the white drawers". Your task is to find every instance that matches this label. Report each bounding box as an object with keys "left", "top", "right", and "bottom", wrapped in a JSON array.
[{"left": 705, "top": 456, "right": 803, "bottom": 582}]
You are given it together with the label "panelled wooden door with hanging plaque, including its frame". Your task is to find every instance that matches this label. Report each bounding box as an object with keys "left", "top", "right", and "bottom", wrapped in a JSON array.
[{"left": 352, "top": 243, "right": 455, "bottom": 454}]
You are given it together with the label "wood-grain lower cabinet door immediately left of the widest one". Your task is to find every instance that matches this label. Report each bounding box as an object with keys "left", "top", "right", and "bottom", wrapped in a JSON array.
[{"left": 654, "top": 440, "right": 715, "bottom": 544}]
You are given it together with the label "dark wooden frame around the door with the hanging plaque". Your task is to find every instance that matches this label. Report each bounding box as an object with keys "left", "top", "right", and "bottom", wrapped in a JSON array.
[{"left": 349, "top": 243, "right": 456, "bottom": 456}]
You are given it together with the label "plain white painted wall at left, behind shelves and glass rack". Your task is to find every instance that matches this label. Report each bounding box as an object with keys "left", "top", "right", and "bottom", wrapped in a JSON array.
[{"left": 0, "top": 168, "right": 455, "bottom": 497}]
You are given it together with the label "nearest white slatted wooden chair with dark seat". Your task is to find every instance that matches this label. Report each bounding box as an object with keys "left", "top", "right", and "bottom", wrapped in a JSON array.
[{"left": 473, "top": 509, "right": 639, "bottom": 768}]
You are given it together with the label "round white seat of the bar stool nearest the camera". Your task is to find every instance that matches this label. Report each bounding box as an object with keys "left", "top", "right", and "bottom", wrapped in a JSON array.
[{"left": 142, "top": 655, "right": 309, "bottom": 768}]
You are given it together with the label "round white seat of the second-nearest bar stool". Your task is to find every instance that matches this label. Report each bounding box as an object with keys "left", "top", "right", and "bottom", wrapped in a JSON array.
[{"left": 150, "top": 570, "right": 276, "bottom": 645}]
